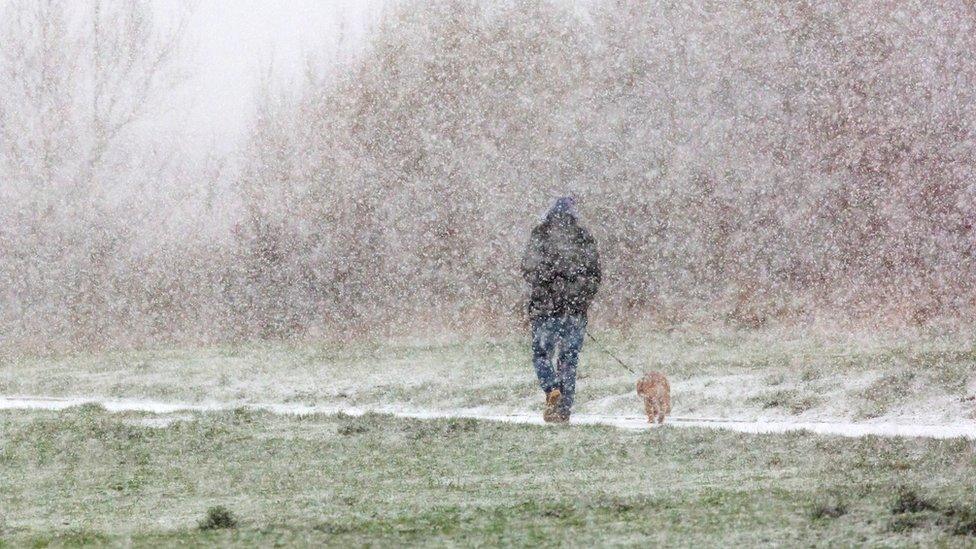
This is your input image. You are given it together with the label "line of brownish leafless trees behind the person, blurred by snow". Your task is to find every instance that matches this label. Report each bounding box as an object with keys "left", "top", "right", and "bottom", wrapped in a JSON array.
[{"left": 0, "top": 0, "right": 976, "bottom": 354}]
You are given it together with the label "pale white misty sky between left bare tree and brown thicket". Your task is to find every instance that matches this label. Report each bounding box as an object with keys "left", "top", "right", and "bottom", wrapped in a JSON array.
[{"left": 173, "top": 0, "right": 383, "bottom": 152}]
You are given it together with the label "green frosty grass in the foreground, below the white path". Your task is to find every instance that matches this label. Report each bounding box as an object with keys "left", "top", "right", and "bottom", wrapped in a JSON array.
[{"left": 0, "top": 406, "right": 976, "bottom": 546}]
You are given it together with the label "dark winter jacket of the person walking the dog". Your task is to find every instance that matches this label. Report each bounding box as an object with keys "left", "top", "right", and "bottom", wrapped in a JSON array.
[{"left": 522, "top": 210, "right": 600, "bottom": 319}]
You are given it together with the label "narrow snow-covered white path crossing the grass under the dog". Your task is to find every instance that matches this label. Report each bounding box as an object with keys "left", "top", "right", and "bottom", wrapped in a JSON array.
[{"left": 0, "top": 396, "right": 976, "bottom": 439}]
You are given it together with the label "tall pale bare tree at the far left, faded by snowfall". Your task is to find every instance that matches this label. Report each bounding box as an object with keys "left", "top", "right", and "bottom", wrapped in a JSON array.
[{"left": 0, "top": 0, "right": 188, "bottom": 352}]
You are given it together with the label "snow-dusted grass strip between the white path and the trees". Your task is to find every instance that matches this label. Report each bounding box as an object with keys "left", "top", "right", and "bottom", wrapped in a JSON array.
[{"left": 0, "top": 329, "right": 976, "bottom": 422}]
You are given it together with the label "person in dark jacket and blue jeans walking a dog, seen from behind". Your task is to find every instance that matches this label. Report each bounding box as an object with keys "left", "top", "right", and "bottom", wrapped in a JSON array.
[{"left": 522, "top": 197, "right": 601, "bottom": 423}]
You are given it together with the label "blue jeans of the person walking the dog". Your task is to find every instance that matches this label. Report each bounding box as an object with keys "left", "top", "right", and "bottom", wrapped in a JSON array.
[{"left": 532, "top": 315, "right": 586, "bottom": 414}]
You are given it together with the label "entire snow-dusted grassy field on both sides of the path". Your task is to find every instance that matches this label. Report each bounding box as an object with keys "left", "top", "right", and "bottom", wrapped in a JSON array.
[{"left": 0, "top": 330, "right": 976, "bottom": 546}]
